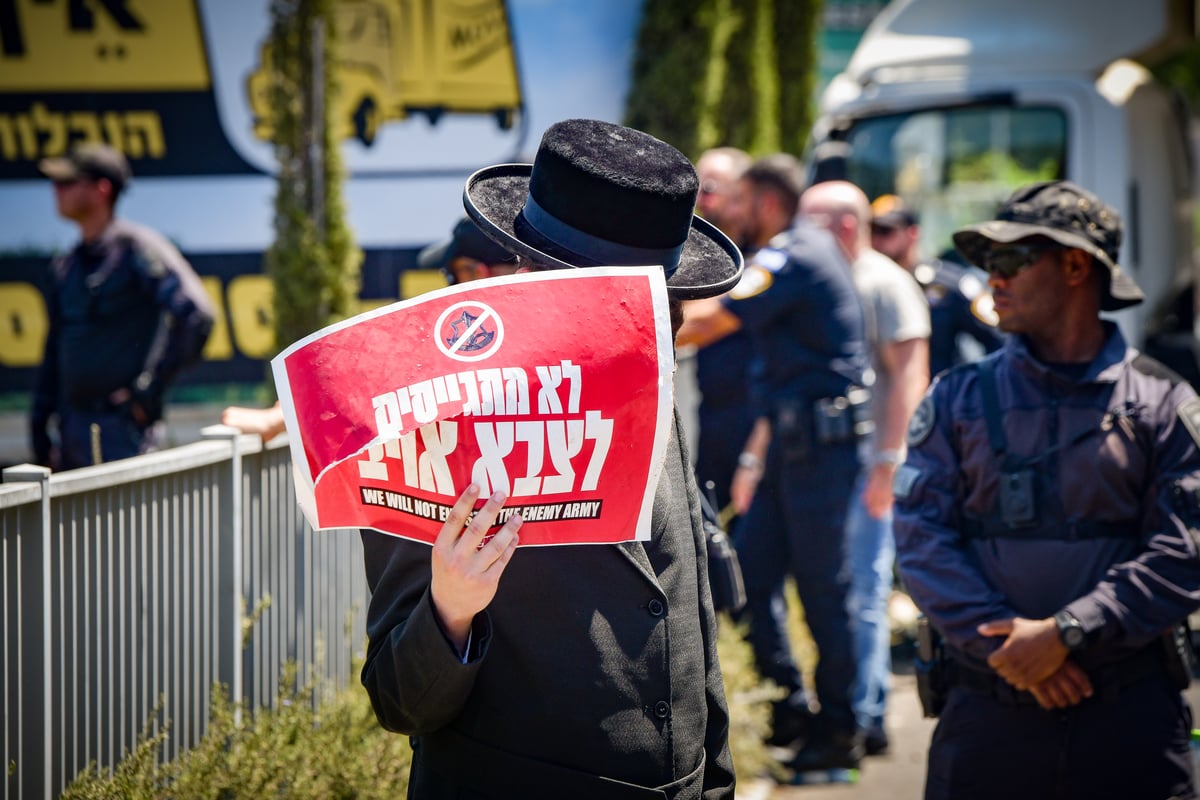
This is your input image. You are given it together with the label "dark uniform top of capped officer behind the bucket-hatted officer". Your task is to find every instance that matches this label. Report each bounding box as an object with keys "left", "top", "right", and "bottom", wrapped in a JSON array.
[{"left": 912, "top": 259, "right": 1004, "bottom": 377}]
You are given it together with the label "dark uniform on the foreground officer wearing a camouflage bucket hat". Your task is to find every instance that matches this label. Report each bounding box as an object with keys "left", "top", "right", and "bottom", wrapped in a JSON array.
[{"left": 895, "top": 323, "right": 1200, "bottom": 800}]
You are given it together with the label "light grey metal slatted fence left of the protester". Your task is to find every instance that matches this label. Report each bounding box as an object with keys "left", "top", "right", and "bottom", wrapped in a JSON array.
[{"left": 0, "top": 426, "right": 368, "bottom": 798}]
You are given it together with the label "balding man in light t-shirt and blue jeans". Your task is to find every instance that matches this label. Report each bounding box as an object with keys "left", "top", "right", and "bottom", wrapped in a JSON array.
[{"left": 800, "top": 181, "right": 930, "bottom": 754}]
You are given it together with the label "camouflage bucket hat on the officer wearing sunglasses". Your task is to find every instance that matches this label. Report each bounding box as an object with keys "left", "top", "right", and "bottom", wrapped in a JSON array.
[{"left": 954, "top": 181, "right": 1145, "bottom": 311}]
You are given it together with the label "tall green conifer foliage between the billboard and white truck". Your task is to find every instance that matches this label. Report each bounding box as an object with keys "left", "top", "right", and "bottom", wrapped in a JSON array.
[{"left": 625, "top": 0, "right": 822, "bottom": 158}]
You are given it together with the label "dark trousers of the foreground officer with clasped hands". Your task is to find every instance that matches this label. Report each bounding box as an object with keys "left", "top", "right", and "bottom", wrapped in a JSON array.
[{"left": 925, "top": 673, "right": 1196, "bottom": 800}]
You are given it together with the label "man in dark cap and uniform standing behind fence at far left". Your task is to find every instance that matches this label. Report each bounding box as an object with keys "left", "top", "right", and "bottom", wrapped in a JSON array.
[{"left": 30, "top": 144, "right": 214, "bottom": 469}]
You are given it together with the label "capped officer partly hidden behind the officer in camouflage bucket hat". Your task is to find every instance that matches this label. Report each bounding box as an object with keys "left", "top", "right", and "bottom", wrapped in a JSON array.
[{"left": 871, "top": 194, "right": 1004, "bottom": 375}]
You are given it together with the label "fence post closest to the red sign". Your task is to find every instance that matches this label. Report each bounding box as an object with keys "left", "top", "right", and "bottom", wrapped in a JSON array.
[{"left": 200, "top": 425, "right": 245, "bottom": 722}]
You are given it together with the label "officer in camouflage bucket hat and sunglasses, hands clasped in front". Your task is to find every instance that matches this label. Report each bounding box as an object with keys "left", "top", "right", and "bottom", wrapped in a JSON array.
[{"left": 895, "top": 181, "right": 1200, "bottom": 800}]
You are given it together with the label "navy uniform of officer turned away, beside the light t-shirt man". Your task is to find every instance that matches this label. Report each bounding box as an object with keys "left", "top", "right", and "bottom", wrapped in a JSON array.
[{"left": 722, "top": 223, "right": 868, "bottom": 734}]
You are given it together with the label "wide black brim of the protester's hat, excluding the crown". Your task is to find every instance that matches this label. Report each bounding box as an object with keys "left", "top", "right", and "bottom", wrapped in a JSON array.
[{"left": 462, "top": 164, "right": 743, "bottom": 300}]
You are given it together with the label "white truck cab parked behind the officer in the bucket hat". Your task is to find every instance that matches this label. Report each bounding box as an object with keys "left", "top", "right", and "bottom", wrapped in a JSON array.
[{"left": 810, "top": 0, "right": 1200, "bottom": 383}]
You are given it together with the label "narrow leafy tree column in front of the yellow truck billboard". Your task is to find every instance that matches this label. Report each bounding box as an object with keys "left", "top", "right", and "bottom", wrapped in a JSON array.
[{"left": 265, "top": 0, "right": 362, "bottom": 357}]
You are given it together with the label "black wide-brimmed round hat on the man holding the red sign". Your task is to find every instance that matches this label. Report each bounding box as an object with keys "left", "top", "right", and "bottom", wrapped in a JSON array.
[{"left": 463, "top": 120, "right": 742, "bottom": 300}]
